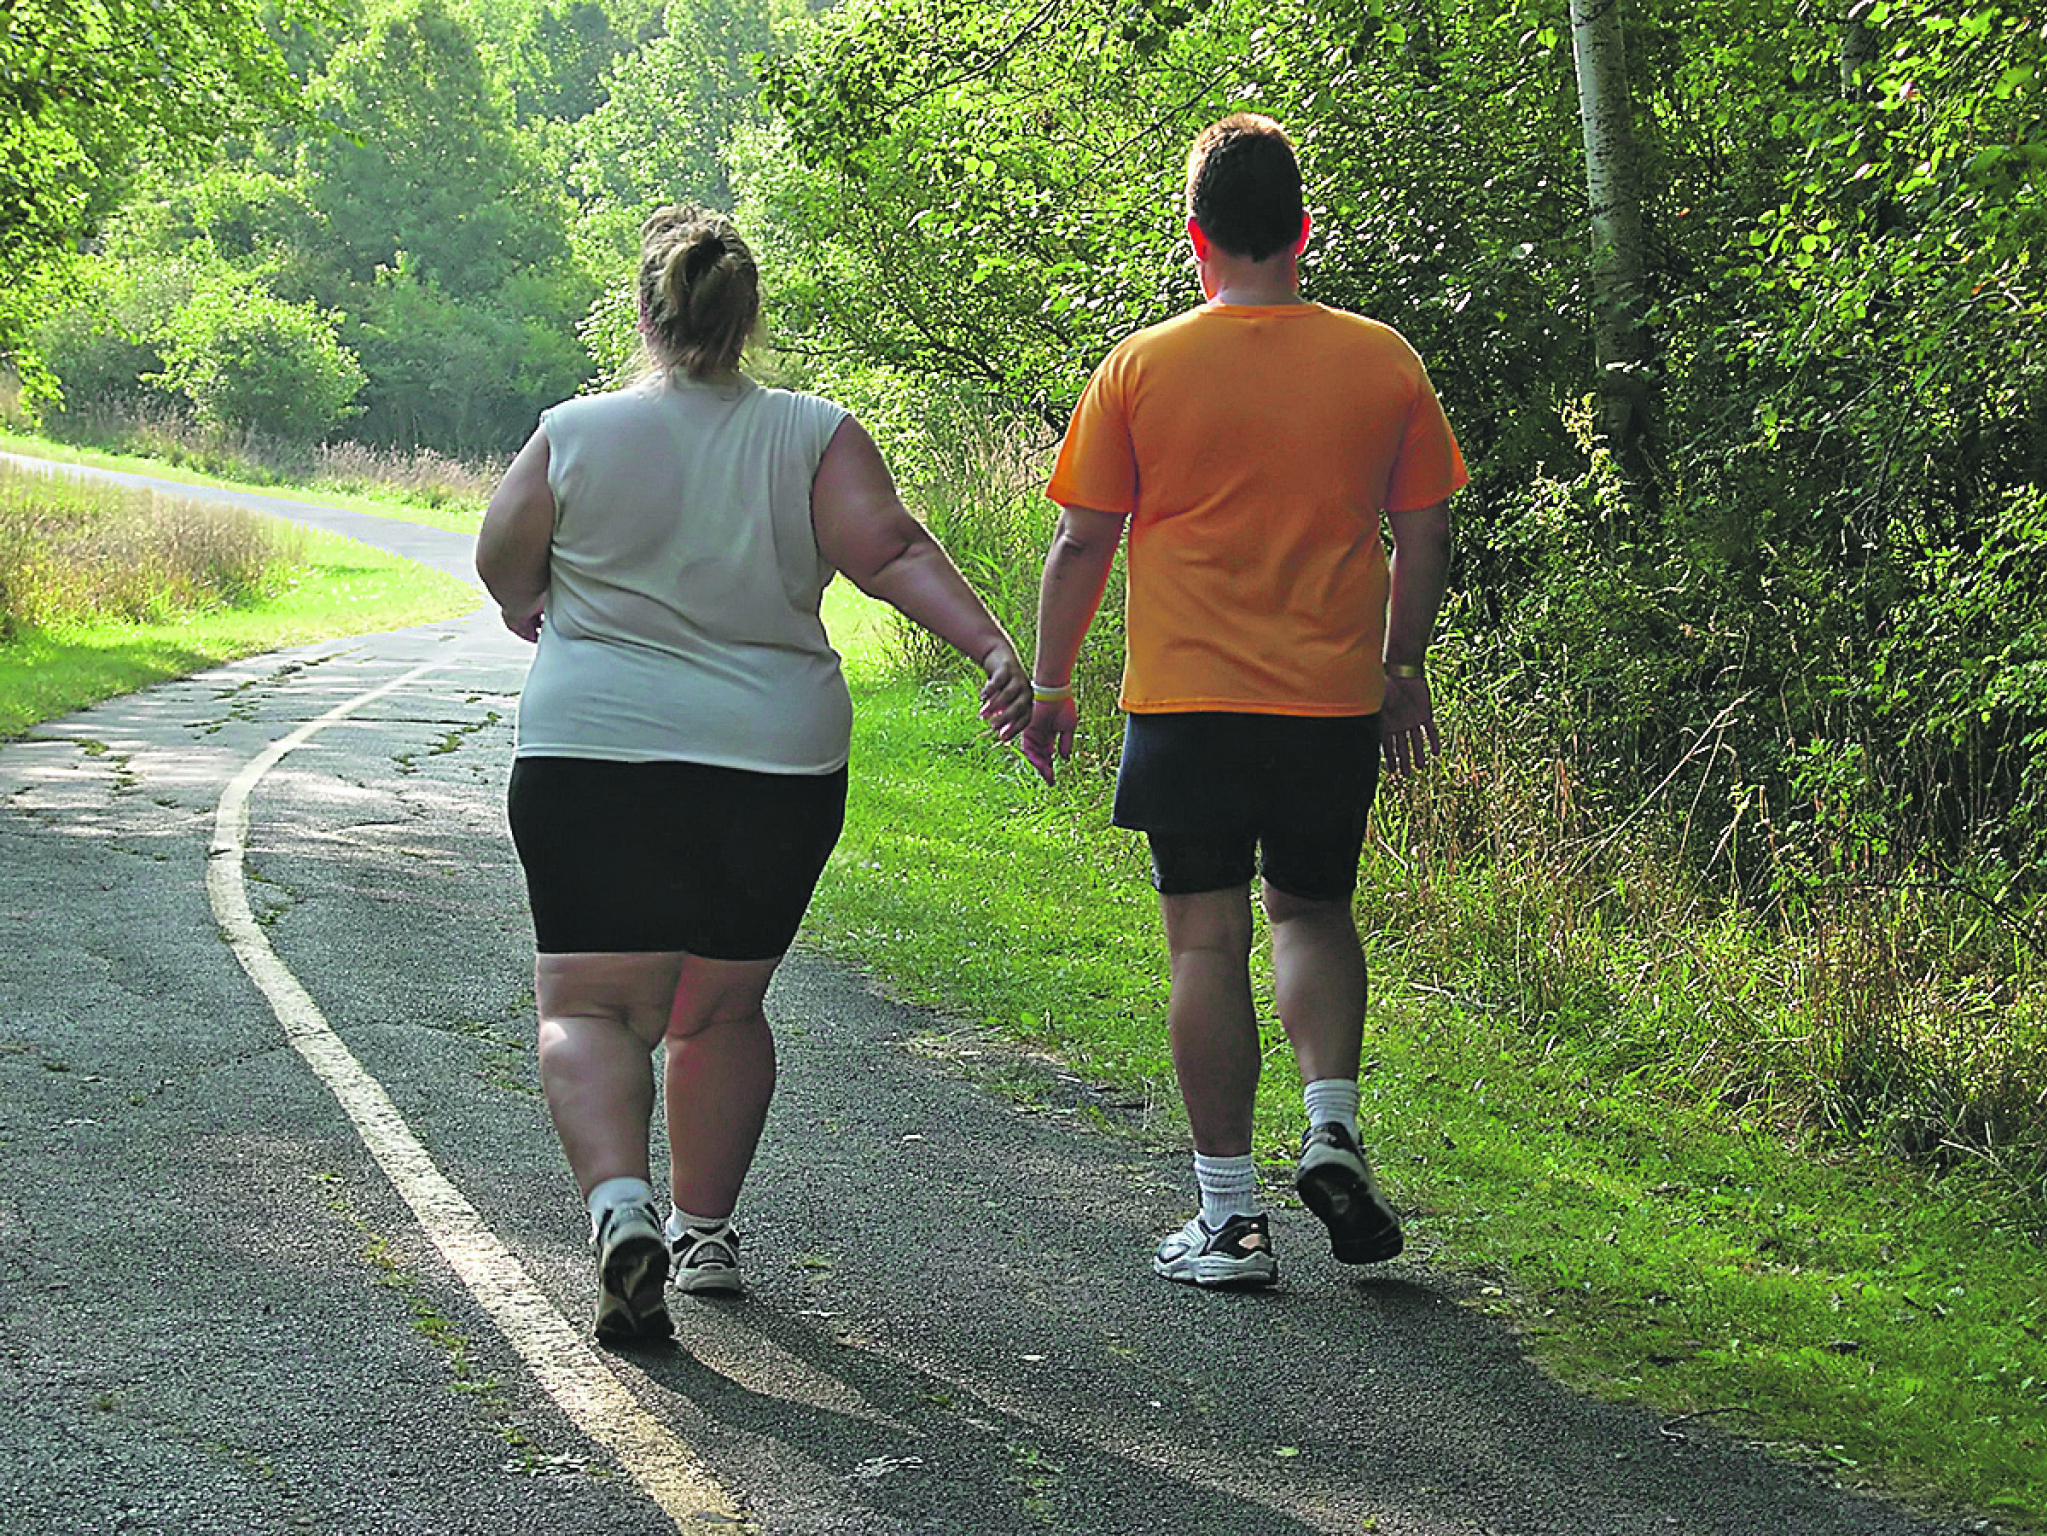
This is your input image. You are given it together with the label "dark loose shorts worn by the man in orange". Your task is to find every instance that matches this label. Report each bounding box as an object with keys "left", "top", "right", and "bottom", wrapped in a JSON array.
[{"left": 1112, "top": 713, "right": 1380, "bottom": 901}]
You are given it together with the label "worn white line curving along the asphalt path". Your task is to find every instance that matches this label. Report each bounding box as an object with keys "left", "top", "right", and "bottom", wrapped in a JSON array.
[{"left": 207, "top": 662, "right": 745, "bottom": 1536}]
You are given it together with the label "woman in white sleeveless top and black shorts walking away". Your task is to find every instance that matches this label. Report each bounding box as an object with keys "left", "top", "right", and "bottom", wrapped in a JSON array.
[{"left": 477, "top": 207, "right": 1032, "bottom": 1339}]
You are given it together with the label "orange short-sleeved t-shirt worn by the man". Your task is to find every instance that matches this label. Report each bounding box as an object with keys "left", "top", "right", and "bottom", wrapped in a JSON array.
[{"left": 1046, "top": 303, "right": 1466, "bottom": 715}]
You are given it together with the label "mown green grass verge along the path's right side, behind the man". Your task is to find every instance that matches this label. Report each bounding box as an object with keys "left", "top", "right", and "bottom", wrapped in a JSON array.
[{"left": 807, "top": 581, "right": 2047, "bottom": 1530}]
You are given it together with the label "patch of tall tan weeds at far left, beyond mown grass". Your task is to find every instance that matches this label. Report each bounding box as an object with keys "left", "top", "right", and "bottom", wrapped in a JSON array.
[{"left": 0, "top": 465, "right": 303, "bottom": 641}]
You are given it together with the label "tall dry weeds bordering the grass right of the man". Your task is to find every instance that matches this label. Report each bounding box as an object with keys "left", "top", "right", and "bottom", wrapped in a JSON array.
[{"left": 1359, "top": 674, "right": 2047, "bottom": 1223}]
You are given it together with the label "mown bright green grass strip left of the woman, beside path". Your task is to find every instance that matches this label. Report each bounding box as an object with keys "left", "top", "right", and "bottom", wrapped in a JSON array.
[{"left": 0, "top": 530, "right": 479, "bottom": 737}]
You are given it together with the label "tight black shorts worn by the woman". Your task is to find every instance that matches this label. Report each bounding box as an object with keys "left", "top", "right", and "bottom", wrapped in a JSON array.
[{"left": 508, "top": 758, "right": 845, "bottom": 961}]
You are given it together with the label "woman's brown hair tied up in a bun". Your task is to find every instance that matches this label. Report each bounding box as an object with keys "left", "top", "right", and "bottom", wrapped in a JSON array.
[{"left": 639, "top": 203, "right": 761, "bottom": 379}]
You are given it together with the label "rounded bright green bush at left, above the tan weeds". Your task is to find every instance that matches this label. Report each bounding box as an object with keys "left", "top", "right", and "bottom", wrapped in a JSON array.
[{"left": 162, "top": 274, "right": 362, "bottom": 442}]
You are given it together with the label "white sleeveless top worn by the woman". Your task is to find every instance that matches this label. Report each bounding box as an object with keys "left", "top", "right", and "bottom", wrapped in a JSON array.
[{"left": 518, "top": 371, "right": 854, "bottom": 774}]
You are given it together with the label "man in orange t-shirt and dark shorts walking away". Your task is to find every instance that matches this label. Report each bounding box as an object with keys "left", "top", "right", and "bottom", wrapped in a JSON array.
[{"left": 1024, "top": 113, "right": 1466, "bottom": 1286}]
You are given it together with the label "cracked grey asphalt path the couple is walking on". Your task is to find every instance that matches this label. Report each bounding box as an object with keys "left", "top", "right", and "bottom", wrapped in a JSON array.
[{"left": 0, "top": 460, "right": 1992, "bottom": 1536}]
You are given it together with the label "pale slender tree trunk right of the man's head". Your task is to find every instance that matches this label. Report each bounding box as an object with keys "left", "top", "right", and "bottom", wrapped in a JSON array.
[{"left": 1570, "top": 0, "right": 1652, "bottom": 489}]
